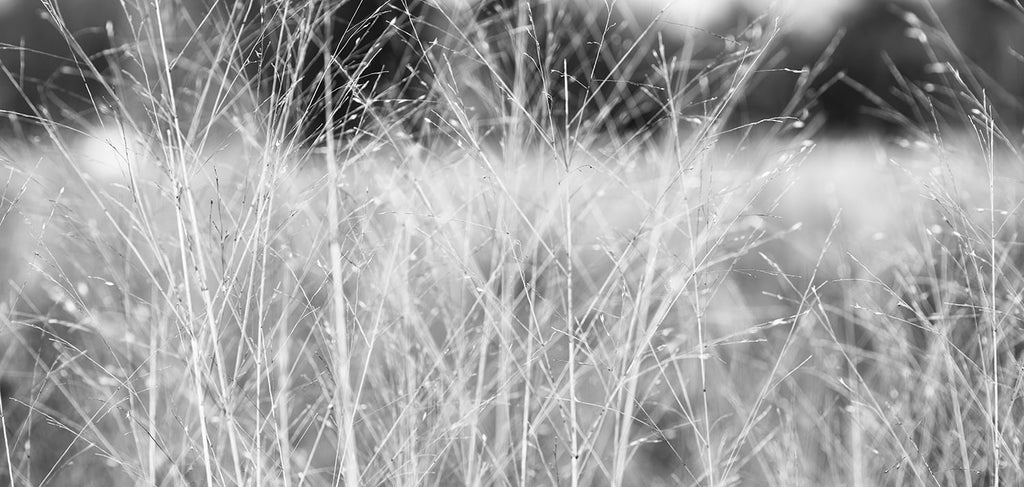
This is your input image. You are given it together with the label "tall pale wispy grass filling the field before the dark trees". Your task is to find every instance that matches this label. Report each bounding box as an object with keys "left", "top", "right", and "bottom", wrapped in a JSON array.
[{"left": 0, "top": 2, "right": 1024, "bottom": 486}]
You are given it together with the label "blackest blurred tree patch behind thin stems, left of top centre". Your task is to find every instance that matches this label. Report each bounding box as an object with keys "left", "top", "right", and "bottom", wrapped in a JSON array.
[{"left": 280, "top": 0, "right": 442, "bottom": 143}]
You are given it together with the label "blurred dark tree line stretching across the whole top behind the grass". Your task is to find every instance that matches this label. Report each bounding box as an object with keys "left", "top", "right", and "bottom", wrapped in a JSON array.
[{"left": 0, "top": 0, "right": 1024, "bottom": 143}]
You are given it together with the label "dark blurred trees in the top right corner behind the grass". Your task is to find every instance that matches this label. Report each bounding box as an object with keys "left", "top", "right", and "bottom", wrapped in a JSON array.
[{"left": 746, "top": 0, "right": 1024, "bottom": 137}]
